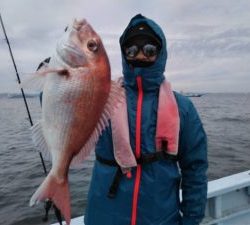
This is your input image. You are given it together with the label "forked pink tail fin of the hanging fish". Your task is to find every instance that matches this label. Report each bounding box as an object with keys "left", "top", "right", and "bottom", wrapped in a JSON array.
[{"left": 30, "top": 173, "right": 71, "bottom": 225}]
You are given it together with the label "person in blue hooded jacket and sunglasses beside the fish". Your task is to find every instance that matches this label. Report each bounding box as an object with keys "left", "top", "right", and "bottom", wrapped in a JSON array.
[{"left": 85, "top": 14, "right": 208, "bottom": 225}]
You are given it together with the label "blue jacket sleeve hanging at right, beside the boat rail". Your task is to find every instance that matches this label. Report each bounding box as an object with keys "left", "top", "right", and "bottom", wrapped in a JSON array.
[{"left": 179, "top": 101, "right": 208, "bottom": 225}]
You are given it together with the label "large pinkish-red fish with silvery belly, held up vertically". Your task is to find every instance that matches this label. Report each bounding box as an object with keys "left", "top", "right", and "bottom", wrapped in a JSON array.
[{"left": 30, "top": 20, "right": 120, "bottom": 224}]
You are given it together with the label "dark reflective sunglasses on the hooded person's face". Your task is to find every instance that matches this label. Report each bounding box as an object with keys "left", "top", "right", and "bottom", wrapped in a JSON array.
[{"left": 124, "top": 44, "right": 159, "bottom": 58}]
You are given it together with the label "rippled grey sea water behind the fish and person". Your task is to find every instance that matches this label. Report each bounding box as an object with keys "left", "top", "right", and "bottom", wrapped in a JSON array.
[{"left": 0, "top": 93, "right": 250, "bottom": 225}]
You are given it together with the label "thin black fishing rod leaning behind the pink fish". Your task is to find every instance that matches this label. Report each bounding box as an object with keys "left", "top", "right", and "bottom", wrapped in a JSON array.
[{"left": 0, "top": 13, "right": 62, "bottom": 225}]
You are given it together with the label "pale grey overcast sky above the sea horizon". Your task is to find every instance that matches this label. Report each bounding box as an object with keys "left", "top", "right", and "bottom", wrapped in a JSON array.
[{"left": 0, "top": 0, "right": 250, "bottom": 92}]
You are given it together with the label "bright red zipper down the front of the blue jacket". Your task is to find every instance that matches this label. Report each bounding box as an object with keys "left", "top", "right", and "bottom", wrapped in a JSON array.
[{"left": 131, "top": 76, "right": 143, "bottom": 225}]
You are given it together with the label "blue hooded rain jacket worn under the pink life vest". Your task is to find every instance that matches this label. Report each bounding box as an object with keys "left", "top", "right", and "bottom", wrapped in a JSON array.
[{"left": 84, "top": 14, "right": 208, "bottom": 225}]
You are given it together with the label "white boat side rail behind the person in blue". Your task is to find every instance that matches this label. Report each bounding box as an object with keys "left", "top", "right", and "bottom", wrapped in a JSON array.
[{"left": 52, "top": 170, "right": 250, "bottom": 225}]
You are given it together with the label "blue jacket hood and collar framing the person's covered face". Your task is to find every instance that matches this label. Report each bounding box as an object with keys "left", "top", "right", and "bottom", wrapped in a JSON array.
[{"left": 120, "top": 14, "right": 167, "bottom": 90}]
